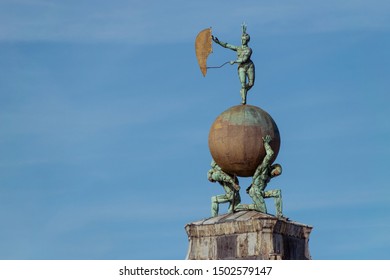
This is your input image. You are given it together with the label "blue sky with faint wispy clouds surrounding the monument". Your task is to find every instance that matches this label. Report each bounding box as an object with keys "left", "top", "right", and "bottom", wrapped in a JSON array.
[{"left": 0, "top": 0, "right": 390, "bottom": 259}]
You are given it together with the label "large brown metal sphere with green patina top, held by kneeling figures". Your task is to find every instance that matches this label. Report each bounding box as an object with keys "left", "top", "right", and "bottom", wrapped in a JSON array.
[{"left": 209, "top": 105, "right": 280, "bottom": 177}]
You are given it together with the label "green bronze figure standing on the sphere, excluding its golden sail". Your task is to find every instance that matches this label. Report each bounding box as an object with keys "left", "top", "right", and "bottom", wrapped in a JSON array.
[{"left": 212, "top": 24, "right": 255, "bottom": 104}]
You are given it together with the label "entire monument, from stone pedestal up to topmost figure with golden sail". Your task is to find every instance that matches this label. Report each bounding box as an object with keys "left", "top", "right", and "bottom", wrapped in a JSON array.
[{"left": 186, "top": 23, "right": 312, "bottom": 260}]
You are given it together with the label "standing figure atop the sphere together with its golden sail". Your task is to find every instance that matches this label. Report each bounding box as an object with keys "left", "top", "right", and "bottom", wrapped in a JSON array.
[{"left": 195, "top": 23, "right": 255, "bottom": 105}]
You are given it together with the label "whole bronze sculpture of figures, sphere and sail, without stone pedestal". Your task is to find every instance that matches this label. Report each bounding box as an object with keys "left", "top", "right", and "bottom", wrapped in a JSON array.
[{"left": 204, "top": 24, "right": 283, "bottom": 218}]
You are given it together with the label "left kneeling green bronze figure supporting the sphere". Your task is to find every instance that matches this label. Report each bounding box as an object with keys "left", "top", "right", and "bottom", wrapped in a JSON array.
[{"left": 207, "top": 160, "right": 241, "bottom": 217}]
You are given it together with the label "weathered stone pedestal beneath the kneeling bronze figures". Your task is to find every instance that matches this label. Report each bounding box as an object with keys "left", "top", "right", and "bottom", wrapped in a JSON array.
[{"left": 185, "top": 211, "right": 312, "bottom": 260}]
